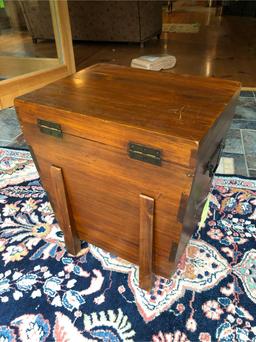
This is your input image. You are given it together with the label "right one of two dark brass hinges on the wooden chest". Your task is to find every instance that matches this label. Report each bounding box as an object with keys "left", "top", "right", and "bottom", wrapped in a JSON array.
[{"left": 128, "top": 142, "right": 162, "bottom": 166}]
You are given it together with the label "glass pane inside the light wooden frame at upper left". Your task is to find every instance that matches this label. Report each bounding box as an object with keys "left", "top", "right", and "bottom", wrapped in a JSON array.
[{"left": 0, "top": 0, "right": 59, "bottom": 81}]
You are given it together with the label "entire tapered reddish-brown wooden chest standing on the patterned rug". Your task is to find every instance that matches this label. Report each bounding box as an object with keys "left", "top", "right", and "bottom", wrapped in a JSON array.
[{"left": 15, "top": 64, "right": 240, "bottom": 289}]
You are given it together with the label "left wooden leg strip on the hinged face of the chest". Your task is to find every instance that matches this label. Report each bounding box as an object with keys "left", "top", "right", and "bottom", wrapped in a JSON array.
[{"left": 50, "top": 165, "right": 81, "bottom": 255}]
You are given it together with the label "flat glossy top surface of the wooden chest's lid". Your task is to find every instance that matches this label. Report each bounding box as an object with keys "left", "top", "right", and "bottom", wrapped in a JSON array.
[{"left": 16, "top": 64, "right": 240, "bottom": 142}]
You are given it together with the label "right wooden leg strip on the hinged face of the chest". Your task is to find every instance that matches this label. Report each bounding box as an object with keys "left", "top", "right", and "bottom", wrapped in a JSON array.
[{"left": 139, "top": 194, "right": 155, "bottom": 291}]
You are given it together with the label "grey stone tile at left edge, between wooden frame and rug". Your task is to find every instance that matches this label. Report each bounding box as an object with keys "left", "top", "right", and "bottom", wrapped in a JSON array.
[{"left": 0, "top": 108, "right": 21, "bottom": 141}]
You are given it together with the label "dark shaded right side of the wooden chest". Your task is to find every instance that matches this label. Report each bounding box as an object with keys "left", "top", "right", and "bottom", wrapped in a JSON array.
[{"left": 176, "top": 87, "right": 239, "bottom": 262}]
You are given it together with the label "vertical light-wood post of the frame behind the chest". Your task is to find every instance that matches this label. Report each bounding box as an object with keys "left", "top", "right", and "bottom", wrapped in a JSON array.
[{"left": 49, "top": 0, "right": 76, "bottom": 74}]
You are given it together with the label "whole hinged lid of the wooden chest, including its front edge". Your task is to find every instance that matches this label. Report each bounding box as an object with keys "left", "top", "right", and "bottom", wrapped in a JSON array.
[{"left": 15, "top": 64, "right": 240, "bottom": 168}]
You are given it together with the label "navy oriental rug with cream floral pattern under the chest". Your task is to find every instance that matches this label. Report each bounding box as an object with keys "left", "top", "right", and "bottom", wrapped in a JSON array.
[{"left": 0, "top": 149, "right": 256, "bottom": 342}]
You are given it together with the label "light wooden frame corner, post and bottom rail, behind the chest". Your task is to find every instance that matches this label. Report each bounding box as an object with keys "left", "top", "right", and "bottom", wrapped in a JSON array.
[{"left": 0, "top": 0, "right": 76, "bottom": 109}]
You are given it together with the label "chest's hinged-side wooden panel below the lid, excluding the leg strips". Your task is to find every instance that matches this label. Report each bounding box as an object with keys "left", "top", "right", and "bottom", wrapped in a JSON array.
[{"left": 23, "top": 117, "right": 192, "bottom": 277}]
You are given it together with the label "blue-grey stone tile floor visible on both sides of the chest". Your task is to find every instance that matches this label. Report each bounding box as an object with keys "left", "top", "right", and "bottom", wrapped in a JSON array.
[{"left": 0, "top": 91, "right": 256, "bottom": 177}]
